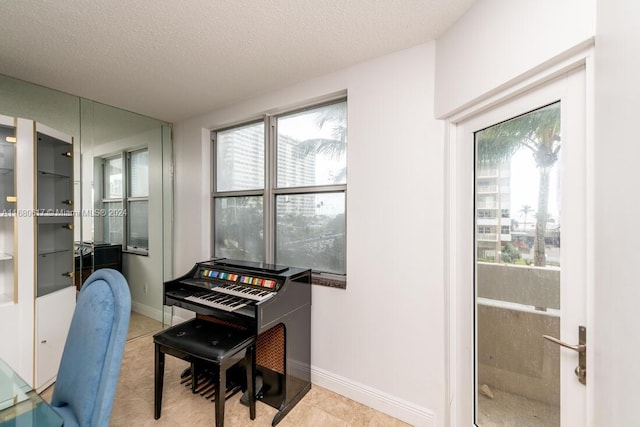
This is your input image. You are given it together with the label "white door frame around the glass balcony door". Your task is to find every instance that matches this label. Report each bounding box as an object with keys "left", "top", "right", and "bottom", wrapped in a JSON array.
[{"left": 444, "top": 45, "right": 596, "bottom": 426}]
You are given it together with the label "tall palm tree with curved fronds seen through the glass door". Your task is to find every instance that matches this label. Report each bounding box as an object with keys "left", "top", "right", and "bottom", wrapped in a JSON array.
[{"left": 476, "top": 102, "right": 561, "bottom": 266}]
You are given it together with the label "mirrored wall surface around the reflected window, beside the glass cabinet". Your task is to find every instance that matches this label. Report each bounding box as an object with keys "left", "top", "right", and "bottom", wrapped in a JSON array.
[{"left": 0, "top": 75, "right": 173, "bottom": 338}]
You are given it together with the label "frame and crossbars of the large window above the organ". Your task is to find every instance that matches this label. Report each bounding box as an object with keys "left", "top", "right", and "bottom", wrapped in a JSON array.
[{"left": 210, "top": 95, "right": 348, "bottom": 289}]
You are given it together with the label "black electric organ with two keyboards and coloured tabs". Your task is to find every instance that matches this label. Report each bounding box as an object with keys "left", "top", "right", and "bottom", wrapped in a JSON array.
[{"left": 164, "top": 259, "right": 311, "bottom": 425}]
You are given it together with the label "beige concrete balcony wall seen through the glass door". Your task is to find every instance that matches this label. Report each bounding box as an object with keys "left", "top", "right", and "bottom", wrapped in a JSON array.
[{"left": 476, "top": 262, "right": 560, "bottom": 406}]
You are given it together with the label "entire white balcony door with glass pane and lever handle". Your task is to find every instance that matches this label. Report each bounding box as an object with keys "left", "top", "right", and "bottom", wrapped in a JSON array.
[{"left": 449, "top": 68, "right": 593, "bottom": 427}]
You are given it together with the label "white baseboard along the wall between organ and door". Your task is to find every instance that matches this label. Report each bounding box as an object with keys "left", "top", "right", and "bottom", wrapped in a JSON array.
[{"left": 311, "top": 366, "right": 435, "bottom": 427}]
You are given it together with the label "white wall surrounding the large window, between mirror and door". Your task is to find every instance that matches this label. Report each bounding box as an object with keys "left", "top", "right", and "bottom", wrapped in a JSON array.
[{"left": 174, "top": 43, "right": 445, "bottom": 425}]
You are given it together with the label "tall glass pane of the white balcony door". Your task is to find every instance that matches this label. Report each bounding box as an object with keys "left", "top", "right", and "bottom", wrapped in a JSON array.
[{"left": 475, "top": 102, "right": 564, "bottom": 426}]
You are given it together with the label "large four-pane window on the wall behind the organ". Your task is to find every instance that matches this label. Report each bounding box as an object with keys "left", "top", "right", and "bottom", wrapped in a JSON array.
[{"left": 212, "top": 100, "right": 347, "bottom": 286}]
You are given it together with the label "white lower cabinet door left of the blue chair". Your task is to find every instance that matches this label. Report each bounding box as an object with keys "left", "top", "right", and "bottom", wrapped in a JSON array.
[{"left": 35, "top": 286, "right": 76, "bottom": 392}]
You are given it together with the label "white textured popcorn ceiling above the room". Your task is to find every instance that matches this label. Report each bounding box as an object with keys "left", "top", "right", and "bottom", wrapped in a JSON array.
[{"left": 0, "top": 0, "right": 473, "bottom": 122}]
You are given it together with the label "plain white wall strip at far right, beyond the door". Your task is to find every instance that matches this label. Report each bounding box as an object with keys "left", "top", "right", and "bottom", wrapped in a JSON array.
[{"left": 590, "top": 0, "right": 640, "bottom": 426}]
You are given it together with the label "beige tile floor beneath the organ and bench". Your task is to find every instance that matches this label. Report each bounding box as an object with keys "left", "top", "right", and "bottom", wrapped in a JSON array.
[{"left": 42, "top": 313, "right": 407, "bottom": 427}]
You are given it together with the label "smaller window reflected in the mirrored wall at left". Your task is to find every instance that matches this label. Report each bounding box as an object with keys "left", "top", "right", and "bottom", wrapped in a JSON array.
[{"left": 102, "top": 148, "right": 149, "bottom": 254}]
